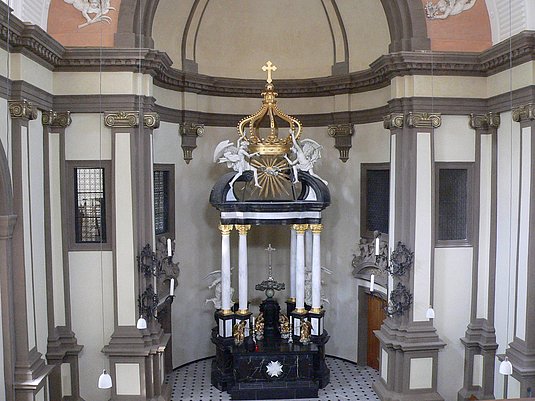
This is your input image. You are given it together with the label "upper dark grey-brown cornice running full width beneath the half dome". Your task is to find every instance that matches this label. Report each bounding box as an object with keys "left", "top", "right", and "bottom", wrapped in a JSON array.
[{"left": 0, "top": 2, "right": 535, "bottom": 98}]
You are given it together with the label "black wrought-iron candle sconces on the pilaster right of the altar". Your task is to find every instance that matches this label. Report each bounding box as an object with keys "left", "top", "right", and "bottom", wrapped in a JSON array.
[{"left": 375, "top": 231, "right": 414, "bottom": 317}]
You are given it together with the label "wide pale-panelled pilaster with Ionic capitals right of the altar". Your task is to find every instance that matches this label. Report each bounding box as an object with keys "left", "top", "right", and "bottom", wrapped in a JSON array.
[{"left": 374, "top": 111, "right": 445, "bottom": 401}]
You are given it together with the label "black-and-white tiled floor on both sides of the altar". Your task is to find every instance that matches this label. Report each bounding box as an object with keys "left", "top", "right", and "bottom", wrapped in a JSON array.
[{"left": 166, "top": 357, "right": 379, "bottom": 401}]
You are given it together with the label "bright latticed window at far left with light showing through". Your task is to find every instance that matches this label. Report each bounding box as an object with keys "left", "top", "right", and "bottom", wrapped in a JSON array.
[{"left": 74, "top": 167, "right": 106, "bottom": 243}]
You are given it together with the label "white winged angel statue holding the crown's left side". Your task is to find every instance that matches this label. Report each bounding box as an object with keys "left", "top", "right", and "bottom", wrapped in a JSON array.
[{"left": 214, "top": 138, "right": 262, "bottom": 188}]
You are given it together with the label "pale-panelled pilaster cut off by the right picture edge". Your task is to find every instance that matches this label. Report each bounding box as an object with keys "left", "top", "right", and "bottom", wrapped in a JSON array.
[{"left": 506, "top": 103, "right": 535, "bottom": 397}]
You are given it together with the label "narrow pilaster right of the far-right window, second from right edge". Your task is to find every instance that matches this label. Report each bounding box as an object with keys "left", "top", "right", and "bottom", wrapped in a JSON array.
[{"left": 458, "top": 112, "right": 500, "bottom": 401}]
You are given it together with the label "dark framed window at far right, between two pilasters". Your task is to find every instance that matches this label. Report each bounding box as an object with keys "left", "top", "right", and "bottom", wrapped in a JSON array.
[{"left": 436, "top": 163, "right": 472, "bottom": 246}]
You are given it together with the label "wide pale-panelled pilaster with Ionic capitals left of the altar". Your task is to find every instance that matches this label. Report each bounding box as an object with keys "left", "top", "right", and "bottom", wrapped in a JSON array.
[{"left": 103, "top": 111, "right": 169, "bottom": 401}]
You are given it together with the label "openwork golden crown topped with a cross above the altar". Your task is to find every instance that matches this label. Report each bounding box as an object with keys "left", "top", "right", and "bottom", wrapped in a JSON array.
[{"left": 238, "top": 61, "right": 302, "bottom": 156}]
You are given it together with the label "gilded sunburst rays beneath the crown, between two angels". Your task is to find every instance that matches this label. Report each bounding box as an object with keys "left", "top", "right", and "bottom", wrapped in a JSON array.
[{"left": 251, "top": 156, "right": 290, "bottom": 198}]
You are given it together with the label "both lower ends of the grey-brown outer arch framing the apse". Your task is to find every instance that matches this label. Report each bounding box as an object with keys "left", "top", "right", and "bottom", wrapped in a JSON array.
[{"left": 115, "top": 0, "right": 431, "bottom": 53}]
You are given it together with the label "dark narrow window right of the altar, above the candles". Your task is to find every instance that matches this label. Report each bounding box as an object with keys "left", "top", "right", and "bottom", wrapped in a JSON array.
[{"left": 360, "top": 163, "right": 390, "bottom": 238}]
